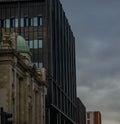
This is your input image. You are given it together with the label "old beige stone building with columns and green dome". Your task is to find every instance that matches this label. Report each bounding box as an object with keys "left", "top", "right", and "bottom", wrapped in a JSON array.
[{"left": 0, "top": 33, "right": 46, "bottom": 124}]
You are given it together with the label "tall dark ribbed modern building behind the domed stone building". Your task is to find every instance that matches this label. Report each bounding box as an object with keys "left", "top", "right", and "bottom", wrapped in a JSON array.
[{"left": 0, "top": 0, "right": 76, "bottom": 124}]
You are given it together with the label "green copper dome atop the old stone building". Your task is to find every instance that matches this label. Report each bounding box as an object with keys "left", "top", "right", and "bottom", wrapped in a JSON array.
[{"left": 17, "top": 35, "right": 31, "bottom": 55}]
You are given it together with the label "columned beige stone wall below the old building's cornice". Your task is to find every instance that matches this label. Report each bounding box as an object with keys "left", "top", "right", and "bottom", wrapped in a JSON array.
[{"left": 0, "top": 56, "right": 45, "bottom": 124}]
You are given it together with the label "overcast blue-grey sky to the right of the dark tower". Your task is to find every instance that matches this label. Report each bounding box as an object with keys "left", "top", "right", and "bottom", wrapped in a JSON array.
[{"left": 61, "top": 0, "right": 120, "bottom": 124}]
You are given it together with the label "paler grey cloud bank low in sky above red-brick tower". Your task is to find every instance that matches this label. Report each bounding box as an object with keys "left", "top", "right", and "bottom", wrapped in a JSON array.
[{"left": 77, "top": 87, "right": 120, "bottom": 124}]
